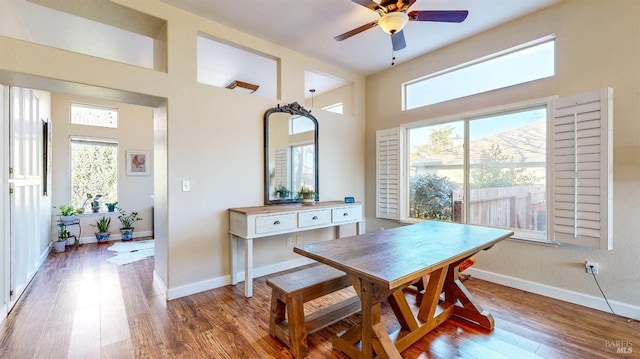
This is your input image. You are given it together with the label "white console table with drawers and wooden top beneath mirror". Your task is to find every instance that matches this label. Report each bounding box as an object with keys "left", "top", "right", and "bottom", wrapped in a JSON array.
[{"left": 229, "top": 201, "right": 364, "bottom": 297}]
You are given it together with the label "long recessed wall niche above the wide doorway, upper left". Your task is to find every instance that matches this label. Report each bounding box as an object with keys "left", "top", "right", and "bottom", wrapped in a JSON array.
[{"left": 0, "top": 0, "right": 166, "bottom": 70}]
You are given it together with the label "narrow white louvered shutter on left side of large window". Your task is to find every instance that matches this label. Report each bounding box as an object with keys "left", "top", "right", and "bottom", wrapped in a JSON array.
[{"left": 376, "top": 128, "right": 402, "bottom": 220}]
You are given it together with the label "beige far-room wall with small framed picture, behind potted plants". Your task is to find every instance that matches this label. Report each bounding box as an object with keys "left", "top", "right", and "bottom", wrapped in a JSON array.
[{"left": 51, "top": 93, "right": 154, "bottom": 243}]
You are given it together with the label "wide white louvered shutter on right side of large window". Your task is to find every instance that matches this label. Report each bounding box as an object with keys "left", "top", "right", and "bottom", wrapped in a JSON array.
[{"left": 549, "top": 88, "right": 613, "bottom": 250}]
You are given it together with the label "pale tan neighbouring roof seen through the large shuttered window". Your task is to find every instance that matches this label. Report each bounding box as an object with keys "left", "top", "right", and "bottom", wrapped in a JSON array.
[{"left": 411, "top": 121, "right": 546, "bottom": 167}]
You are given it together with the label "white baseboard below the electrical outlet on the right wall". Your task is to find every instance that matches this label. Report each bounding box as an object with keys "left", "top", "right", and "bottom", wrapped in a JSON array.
[{"left": 465, "top": 268, "right": 640, "bottom": 320}]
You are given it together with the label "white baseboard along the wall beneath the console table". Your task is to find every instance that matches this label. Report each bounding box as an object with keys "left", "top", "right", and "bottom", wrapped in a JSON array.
[{"left": 167, "top": 258, "right": 314, "bottom": 300}]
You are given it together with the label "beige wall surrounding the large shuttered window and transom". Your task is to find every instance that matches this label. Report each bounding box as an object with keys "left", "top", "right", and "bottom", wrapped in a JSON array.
[{"left": 365, "top": 0, "right": 640, "bottom": 317}]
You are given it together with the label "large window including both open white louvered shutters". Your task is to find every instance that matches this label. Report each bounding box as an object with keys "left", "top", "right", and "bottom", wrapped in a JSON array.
[{"left": 376, "top": 88, "right": 613, "bottom": 250}]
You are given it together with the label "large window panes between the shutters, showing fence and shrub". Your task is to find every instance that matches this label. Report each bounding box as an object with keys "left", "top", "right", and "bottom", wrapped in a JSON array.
[{"left": 408, "top": 106, "right": 547, "bottom": 240}]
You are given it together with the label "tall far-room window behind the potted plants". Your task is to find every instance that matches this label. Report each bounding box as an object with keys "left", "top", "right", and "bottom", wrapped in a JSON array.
[{"left": 70, "top": 137, "right": 118, "bottom": 210}]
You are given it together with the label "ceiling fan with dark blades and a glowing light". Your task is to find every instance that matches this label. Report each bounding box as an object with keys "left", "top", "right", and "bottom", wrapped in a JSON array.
[{"left": 334, "top": 0, "right": 469, "bottom": 51}]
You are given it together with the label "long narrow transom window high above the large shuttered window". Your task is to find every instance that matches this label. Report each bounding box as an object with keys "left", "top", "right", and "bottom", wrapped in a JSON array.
[{"left": 404, "top": 37, "right": 555, "bottom": 110}]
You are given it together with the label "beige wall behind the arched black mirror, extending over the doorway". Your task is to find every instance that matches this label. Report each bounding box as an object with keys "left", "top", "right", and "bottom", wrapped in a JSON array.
[{"left": 0, "top": 0, "right": 365, "bottom": 297}]
